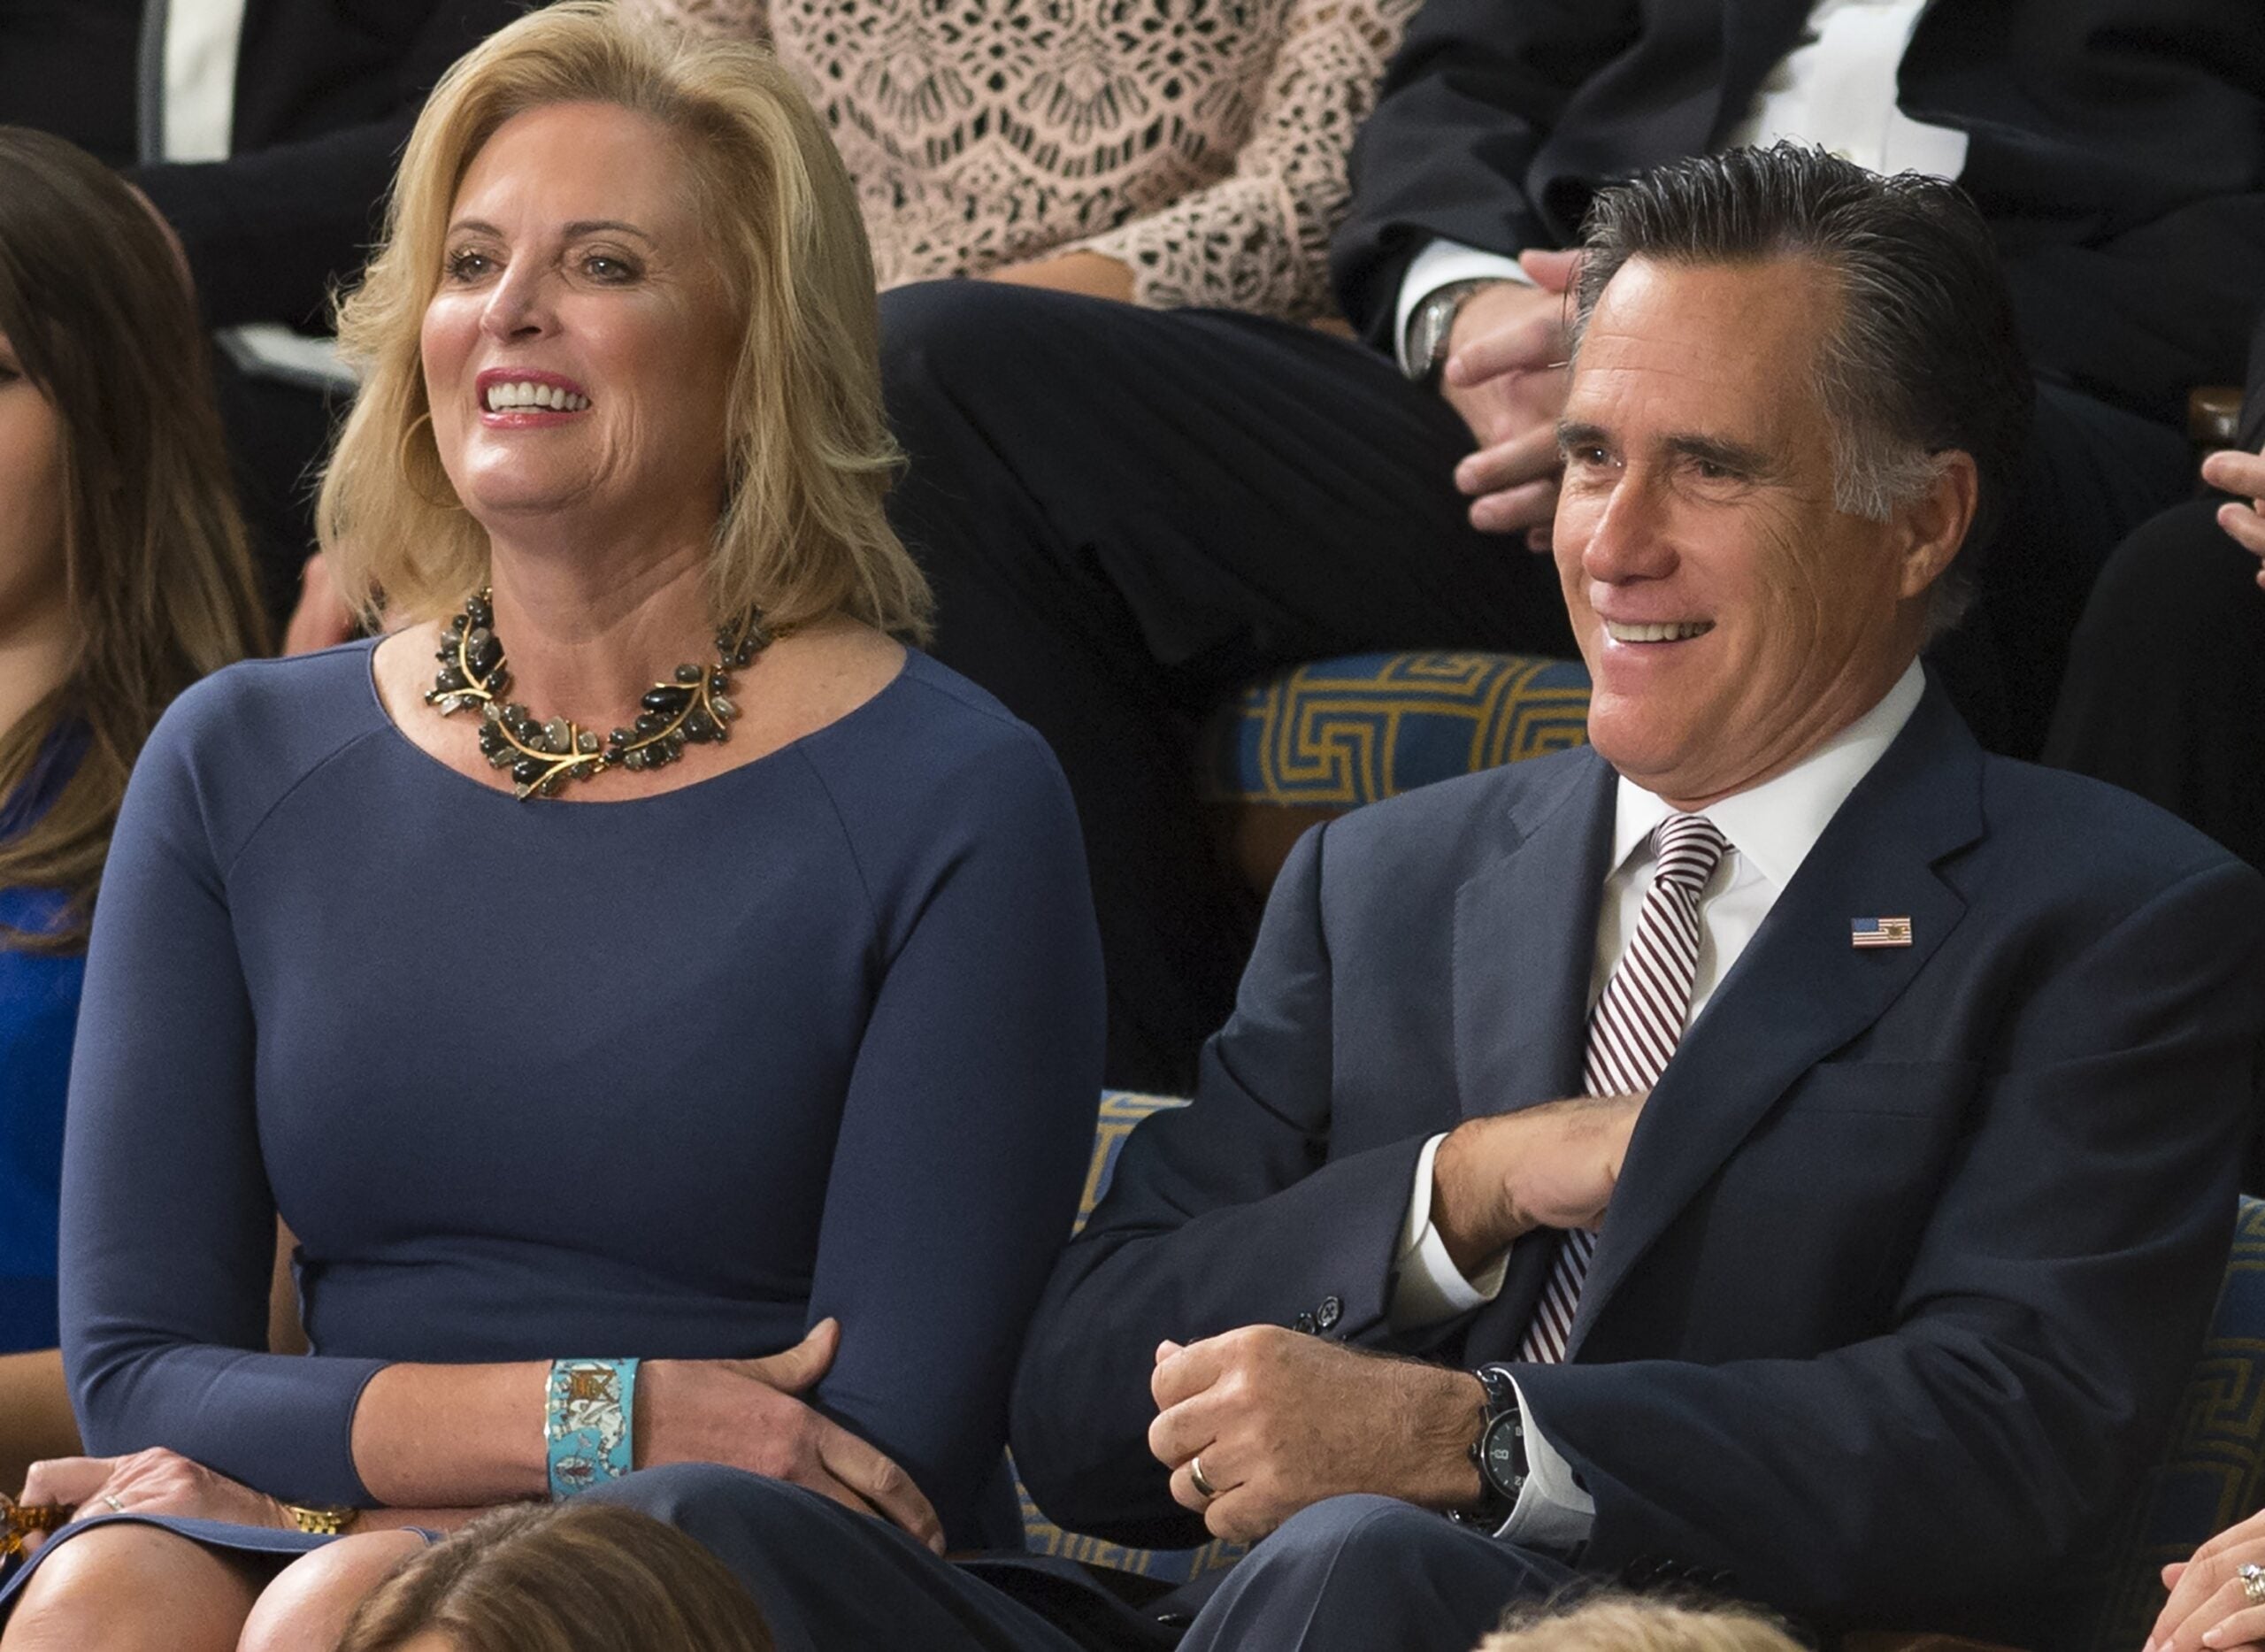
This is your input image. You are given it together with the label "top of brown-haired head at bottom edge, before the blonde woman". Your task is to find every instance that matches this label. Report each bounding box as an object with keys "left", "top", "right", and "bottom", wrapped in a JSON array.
[{"left": 337, "top": 1502, "right": 772, "bottom": 1652}]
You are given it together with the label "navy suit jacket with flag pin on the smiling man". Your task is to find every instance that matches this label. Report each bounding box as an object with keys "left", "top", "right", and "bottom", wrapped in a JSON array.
[{"left": 1012, "top": 687, "right": 2265, "bottom": 1645}]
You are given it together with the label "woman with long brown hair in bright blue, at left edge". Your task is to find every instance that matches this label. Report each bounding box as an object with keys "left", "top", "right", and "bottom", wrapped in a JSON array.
[{"left": 0, "top": 127, "right": 260, "bottom": 1491}]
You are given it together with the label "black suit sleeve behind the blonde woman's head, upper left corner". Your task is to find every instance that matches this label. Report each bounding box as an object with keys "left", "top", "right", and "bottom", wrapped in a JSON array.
[{"left": 127, "top": 0, "right": 527, "bottom": 327}]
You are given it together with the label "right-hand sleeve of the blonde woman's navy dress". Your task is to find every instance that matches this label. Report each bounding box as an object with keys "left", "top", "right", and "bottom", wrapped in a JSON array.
[{"left": 810, "top": 727, "right": 1103, "bottom": 1546}]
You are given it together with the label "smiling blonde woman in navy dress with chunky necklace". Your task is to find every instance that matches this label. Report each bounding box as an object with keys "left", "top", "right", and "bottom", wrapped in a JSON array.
[{"left": 0, "top": 4, "right": 1101, "bottom": 1652}]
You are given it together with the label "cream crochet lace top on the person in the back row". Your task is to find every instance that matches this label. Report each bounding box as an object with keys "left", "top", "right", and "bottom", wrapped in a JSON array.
[{"left": 627, "top": 0, "right": 1413, "bottom": 319}]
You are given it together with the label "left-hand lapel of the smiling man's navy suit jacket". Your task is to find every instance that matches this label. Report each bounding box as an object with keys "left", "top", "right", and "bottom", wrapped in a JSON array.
[{"left": 1452, "top": 748, "right": 1615, "bottom": 1118}]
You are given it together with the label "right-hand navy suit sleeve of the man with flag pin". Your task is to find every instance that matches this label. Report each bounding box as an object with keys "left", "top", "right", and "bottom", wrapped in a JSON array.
[{"left": 1520, "top": 864, "right": 2265, "bottom": 1639}]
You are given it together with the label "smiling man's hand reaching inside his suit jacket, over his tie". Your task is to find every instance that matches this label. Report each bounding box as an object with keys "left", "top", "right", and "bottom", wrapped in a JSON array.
[{"left": 1432, "top": 1090, "right": 1651, "bottom": 1276}]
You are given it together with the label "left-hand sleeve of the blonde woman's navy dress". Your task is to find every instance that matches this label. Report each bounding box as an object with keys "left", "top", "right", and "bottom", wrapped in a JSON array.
[{"left": 61, "top": 682, "right": 383, "bottom": 1502}]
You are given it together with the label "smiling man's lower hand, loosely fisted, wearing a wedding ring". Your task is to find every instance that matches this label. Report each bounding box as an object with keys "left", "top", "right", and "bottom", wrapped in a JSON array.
[{"left": 1148, "top": 1325, "right": 1486, "bottom": 1543}]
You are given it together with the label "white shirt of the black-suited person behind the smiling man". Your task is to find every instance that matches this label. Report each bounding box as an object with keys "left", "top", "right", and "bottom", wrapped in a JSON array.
[{"left": 1393, "top": 0, "right": 1966, "bottom": 367}]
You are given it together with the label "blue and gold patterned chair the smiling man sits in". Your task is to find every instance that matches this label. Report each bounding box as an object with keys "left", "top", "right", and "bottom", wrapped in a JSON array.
[{"left": 1015, "top": 1090, "right": 2265, "bottom": 1652}]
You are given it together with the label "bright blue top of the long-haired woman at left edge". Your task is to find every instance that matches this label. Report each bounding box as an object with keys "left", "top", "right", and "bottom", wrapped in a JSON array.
[{"left": 0, "top": 726, "right": 86, "bottom": 1350}]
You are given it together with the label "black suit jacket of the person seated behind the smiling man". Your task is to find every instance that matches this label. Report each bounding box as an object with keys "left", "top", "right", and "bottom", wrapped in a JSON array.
[{"left": 1332, "top": 0, "right": 2265, "bottom": 424}]
